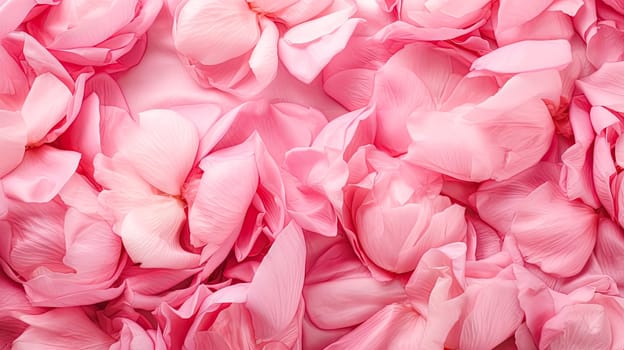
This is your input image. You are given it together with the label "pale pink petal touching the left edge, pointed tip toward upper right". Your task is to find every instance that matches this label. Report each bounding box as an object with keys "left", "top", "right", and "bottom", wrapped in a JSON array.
[{"left": 2, "top": 145, "right": 80, "bottom": 203}]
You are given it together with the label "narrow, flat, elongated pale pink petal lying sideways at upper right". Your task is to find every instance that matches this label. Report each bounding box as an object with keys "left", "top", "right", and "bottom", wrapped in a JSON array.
[{"left": 471, "top": 39, "right": 572, "bottom": 73}]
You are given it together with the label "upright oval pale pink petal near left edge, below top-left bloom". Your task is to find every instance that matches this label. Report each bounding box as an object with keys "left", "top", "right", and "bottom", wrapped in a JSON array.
[{"left": 22, "top": 73, "right": 72, "bottom": 144}]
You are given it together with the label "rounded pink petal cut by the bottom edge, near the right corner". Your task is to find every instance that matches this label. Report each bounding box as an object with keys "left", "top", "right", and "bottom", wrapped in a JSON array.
[{"left": 540, "top": 304, "right": 613, "bottom": 350}]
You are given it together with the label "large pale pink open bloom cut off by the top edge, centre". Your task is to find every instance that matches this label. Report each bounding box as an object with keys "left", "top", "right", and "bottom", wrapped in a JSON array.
[{"left": 171, "top": 0, "right": 358, "bottom": 95}]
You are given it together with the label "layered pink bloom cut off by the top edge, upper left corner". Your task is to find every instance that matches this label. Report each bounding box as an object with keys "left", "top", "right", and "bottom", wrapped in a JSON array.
[{"left": 25, "top": 0, "right": 162, "bottom": 72}]
